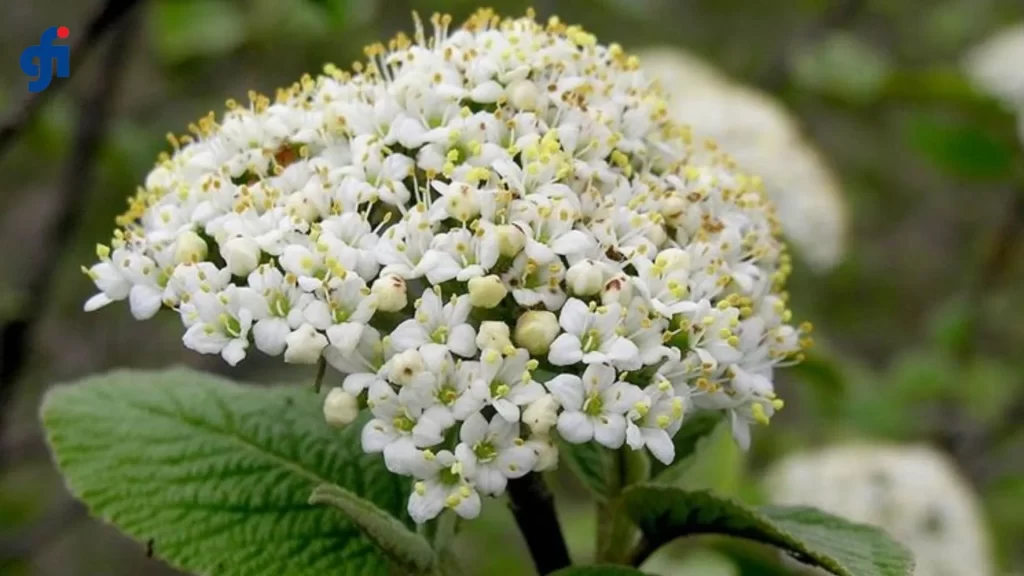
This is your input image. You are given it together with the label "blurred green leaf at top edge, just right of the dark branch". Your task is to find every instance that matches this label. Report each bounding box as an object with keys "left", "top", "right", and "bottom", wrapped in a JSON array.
[{"left": 152, "top": 0, "right": 246, "bottom": 64}]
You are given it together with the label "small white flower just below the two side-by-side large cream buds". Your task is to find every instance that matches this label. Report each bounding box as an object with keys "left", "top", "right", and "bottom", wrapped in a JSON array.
[{"left": 474, "top": 348, "right": 544, "bottom": 422}]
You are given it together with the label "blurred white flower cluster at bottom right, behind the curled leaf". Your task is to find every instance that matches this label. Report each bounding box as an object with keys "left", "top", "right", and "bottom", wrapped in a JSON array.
[{"left": 767, "top": 445, "right": 995, "bottom": 576}]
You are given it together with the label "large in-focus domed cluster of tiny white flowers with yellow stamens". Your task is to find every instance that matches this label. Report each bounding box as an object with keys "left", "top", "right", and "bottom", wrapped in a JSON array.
[{"left": 86, "top": 11, "right": 809, "bottom": 522}]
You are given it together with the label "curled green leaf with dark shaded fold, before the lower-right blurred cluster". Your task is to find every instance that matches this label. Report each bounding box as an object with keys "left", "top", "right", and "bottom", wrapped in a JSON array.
[{"left": 623, "top": 485, "right": 913, "bottom": 576}]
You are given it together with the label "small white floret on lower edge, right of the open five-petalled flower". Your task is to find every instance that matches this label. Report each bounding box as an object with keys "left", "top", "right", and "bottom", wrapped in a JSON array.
[{"left": 626, "top": 379, "right": 685, "bottom": 465}]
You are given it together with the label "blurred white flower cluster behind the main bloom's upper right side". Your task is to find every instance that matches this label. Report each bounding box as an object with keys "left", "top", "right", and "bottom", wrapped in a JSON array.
[{"left": 640, "top": 48, "right": 850, "bottom": 271}]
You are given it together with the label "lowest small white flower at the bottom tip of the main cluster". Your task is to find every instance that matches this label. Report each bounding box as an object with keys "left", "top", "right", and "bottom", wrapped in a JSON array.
[{"left": 408, "top": 450, "right": 480, "bottom": 524}]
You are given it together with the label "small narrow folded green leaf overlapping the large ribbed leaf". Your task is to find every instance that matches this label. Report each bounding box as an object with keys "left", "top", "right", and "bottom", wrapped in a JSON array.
[{"left": 309, "top": 484, "right": 436, "bottom": 573}]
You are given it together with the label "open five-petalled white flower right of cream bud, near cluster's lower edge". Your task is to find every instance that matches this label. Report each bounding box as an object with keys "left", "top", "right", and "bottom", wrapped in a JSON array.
[{"left": 547, "top": 364, "right": 644, "bottom": 448}]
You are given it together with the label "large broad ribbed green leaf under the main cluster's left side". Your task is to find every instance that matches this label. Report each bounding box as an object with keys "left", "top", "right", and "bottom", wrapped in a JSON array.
[{"left": 42, "top": 369, "right": 408, "bottom": 576}]
